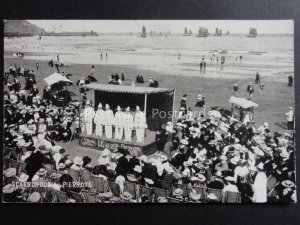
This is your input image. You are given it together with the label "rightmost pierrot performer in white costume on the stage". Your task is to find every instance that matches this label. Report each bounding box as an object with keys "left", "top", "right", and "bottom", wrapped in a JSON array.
[{"left": 133, "top": 106, "right": 148, "bottom": 143}]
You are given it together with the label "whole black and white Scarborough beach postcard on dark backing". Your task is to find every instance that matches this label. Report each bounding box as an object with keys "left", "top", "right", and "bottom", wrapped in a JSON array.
[{"left": 2, "top": 20, "right": 297, "bottom": 203}]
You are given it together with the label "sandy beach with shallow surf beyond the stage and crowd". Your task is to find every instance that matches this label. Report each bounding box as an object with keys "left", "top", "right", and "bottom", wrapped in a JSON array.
[{"left": 4, "top": 33, "right": 294, "bottom": 163}]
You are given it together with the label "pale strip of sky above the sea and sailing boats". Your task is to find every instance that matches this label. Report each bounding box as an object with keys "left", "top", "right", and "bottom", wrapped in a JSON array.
[{"left": 28, "top": 20, "right": 294, "bottom": 34}]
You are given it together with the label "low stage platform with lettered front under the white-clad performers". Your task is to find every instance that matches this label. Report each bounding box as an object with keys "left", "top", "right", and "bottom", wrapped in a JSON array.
[{"left": 79, "top": 130, "right": 156, "bottom": 155}]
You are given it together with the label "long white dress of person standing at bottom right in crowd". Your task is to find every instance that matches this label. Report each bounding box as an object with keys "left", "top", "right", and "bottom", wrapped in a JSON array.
[{"left": 253, "top": 172, "right": 267, "bottom": 203}]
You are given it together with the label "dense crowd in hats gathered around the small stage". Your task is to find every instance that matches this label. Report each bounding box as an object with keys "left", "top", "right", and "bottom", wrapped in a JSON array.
[{"left": 2, "top": 60, "right": 296, "bottom": 203}]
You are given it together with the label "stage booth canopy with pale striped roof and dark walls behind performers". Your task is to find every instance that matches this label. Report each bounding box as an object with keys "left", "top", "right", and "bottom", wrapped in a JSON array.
[{"left": 82, "top": 83, "right": 175, "bottom": 131}]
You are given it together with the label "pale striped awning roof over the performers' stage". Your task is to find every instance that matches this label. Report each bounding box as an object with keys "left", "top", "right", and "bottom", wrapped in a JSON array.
[{"left": 82, "top": 83, "right": 174, "bottom": 94}]
